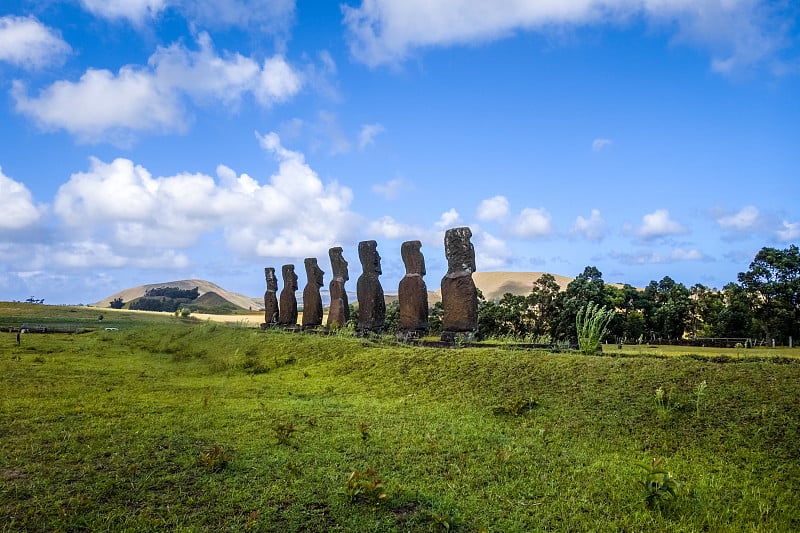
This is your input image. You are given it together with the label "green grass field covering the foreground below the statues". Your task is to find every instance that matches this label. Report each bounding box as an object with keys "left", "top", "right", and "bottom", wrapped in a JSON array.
[{"left": 0, "top": 304, "right": 800, "bottom": 532}]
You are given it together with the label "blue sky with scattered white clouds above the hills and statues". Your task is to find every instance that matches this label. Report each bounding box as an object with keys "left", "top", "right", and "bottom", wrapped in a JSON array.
[{"left": 0, "top": 0, "right": 800, "bottom": 303}]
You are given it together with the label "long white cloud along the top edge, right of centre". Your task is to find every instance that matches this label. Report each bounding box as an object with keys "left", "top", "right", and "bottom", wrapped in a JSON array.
[{"left": 342, "top": 0, "right": 791, "bottom": 72}]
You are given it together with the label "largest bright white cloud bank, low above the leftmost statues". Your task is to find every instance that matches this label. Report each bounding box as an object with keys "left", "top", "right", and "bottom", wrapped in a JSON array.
[{"left": 48, "top": 133, "right": 356, "bottom": 266}]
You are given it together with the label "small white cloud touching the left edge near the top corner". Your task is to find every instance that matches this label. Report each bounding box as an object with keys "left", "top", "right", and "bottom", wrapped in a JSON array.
[{"left": 0, "top": 16, "right": 72, "bottom": 69}]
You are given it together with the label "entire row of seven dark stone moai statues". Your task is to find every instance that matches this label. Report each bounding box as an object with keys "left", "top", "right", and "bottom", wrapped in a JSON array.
[{"left": 264, "top": 227, "right": 478, "bottom": 341}]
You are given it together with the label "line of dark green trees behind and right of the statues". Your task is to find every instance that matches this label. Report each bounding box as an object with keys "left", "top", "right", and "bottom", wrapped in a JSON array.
[{"left": 386, "top": 245, "right": 800, "bottom": 345}]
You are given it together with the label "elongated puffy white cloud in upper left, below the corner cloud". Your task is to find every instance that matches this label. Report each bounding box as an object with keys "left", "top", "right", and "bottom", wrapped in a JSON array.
[{"left": 12, "top": 33, "right": 302, "bottom": 143}]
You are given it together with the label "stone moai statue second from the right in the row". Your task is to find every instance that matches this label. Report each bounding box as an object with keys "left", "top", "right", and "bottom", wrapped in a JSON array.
[{"left": 397, "top": 241, "right": 428, "bottom": 340}]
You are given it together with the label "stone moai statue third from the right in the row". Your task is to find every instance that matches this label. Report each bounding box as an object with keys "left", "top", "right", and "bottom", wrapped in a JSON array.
[{"left": 356, "top": 241, "right": 386, "bottom": 337}]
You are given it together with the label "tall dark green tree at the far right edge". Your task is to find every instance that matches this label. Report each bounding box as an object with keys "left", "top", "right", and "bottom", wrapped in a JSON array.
[{"left": 738, "top": 244, "right": 800, "bottom": 340}]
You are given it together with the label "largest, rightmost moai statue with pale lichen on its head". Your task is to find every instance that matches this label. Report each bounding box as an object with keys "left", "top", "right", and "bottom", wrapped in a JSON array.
[{"left": 442, "top": 227, "right": 478, "bottom": 342}]
